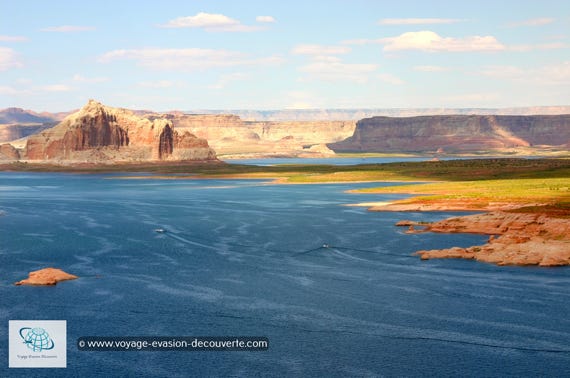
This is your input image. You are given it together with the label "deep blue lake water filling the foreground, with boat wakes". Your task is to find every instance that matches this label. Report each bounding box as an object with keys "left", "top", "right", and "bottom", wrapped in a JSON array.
[{"left": 0, "top": 173, "right": 570, "bottom": 377}]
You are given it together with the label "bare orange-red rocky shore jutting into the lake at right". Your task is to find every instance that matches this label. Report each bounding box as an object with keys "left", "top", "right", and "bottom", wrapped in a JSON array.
[{"left": 392, "top": 211, "right": 570, "bottom": 267}]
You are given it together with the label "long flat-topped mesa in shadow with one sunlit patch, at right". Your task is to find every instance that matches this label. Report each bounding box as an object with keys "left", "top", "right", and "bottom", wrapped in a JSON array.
[{"left": 329, "top": 114, "right": 570, "bottom": 152}]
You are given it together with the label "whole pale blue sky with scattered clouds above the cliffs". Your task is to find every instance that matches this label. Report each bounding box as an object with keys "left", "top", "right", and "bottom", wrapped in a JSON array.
[{"left": 0, "top": 0, "right": 570, "bottom": 111}]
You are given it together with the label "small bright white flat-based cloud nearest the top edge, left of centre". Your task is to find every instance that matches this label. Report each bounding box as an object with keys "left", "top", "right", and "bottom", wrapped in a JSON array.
[{"left": 159, "top": 12, "right": 260, "bottom": 32}]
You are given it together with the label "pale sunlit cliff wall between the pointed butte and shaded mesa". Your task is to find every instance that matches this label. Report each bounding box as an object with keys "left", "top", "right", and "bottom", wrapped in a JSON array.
[{"left": 160, "top": 114, "right": 356, "bottom": 156}]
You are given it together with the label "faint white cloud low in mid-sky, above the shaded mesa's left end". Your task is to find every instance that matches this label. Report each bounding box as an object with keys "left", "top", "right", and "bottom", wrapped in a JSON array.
[{"left": 299, "top": 59, "right": 378, "bottom": 83}]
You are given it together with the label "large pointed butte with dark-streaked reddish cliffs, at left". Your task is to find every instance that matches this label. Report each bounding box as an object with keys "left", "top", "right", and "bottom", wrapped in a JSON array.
[{"left": 22, "top": 100, "right": 216, "bottom": 162}]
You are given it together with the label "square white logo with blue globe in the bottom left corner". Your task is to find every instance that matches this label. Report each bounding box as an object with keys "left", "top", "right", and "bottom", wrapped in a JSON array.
[{"left": 8, "top": 320, "right": 67, "bottom": 368}]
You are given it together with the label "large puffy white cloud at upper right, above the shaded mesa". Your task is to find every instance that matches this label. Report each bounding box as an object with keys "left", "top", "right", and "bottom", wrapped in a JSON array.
[{"left": 379, "top": 31, "right": 505, "bottom": 52}]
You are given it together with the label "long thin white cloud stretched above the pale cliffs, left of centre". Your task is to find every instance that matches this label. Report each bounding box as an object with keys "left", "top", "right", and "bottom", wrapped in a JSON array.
[{"left": 99, "top": 48, "right": 283, "bottom": 71}]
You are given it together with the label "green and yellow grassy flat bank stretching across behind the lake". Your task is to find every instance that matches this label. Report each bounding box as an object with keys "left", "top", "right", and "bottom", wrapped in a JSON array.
[{"left": 5, "top": 158, "right": 570, "bottom": 216}]
